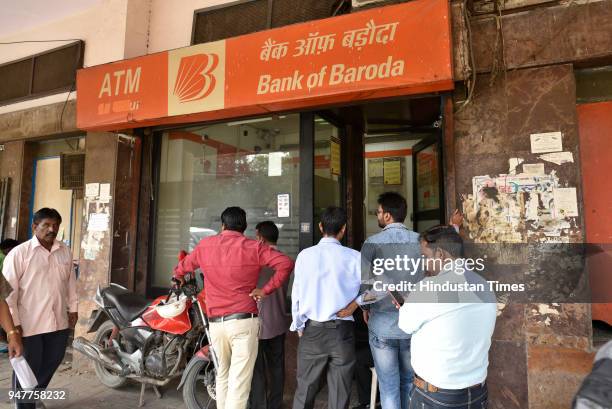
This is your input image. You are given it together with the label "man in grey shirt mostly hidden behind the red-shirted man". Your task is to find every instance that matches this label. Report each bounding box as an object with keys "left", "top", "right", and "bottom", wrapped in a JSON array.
[{"left": 249, "top": 221, "right": 291, "bottom": 409}]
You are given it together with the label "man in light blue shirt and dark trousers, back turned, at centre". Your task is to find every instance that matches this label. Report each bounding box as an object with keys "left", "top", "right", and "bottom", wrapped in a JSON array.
[{"left": 291, "top": 207, "right": 361, "bottom": 409}]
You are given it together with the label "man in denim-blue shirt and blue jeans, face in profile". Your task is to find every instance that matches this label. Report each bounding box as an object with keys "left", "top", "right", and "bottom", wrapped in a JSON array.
[{"left": 338, "top": 192, "right": 422, "bottom": 409}]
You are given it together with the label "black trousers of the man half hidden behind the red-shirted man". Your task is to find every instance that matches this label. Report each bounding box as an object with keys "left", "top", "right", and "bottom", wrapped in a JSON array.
[{"left": 249, "top": 334, "right": 285, "bottom": 409}]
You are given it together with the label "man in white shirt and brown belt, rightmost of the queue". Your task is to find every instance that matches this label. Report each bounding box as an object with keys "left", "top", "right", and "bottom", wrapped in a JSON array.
[{"left": 399, "top": 226, "right": 497, "bottom": 409}]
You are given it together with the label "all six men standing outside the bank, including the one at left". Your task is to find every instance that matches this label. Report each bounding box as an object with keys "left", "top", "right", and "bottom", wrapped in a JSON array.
[{"left": 0, "top": 199, "right": 496, "bottom": 409}]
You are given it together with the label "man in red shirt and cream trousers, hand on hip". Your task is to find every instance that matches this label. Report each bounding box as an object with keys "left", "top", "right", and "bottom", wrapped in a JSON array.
[{"left": 174, "top": 207, "right": 293, "bottom": 409}]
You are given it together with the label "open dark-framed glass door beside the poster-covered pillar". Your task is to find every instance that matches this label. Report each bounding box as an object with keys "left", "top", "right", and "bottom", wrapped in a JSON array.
[{"left": 412, "top": 132, "right": 444, "bottom": 233}]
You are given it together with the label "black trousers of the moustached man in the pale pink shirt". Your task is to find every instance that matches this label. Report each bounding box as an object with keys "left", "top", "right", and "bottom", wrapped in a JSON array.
[{"left": 13, "top": 329, "right": 70, "bottom": 409}]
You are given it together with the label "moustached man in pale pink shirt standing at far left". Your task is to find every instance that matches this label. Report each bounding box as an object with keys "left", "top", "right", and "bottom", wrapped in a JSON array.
[{"left": 2, "top": 208, "right": 78, "bottom": 409}]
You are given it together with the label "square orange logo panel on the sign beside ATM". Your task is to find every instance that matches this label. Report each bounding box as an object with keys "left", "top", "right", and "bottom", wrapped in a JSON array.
[{"left": 168, "top": 41, "right": 225, "bottom": 115}]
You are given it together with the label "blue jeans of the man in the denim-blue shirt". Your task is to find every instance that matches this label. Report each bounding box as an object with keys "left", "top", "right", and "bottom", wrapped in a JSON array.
[{"left": 370, "top": 333, "right": 414, "bottom": 409}]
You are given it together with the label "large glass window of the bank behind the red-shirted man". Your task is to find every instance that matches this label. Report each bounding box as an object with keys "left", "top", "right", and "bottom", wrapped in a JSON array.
[{"left": 151, "top": 114, "right": 300, "bottom": 287}]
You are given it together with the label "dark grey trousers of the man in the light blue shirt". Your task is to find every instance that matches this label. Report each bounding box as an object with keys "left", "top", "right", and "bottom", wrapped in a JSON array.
[{"left": 293, "top": 320, "right": 355, "bottom": 409}]
